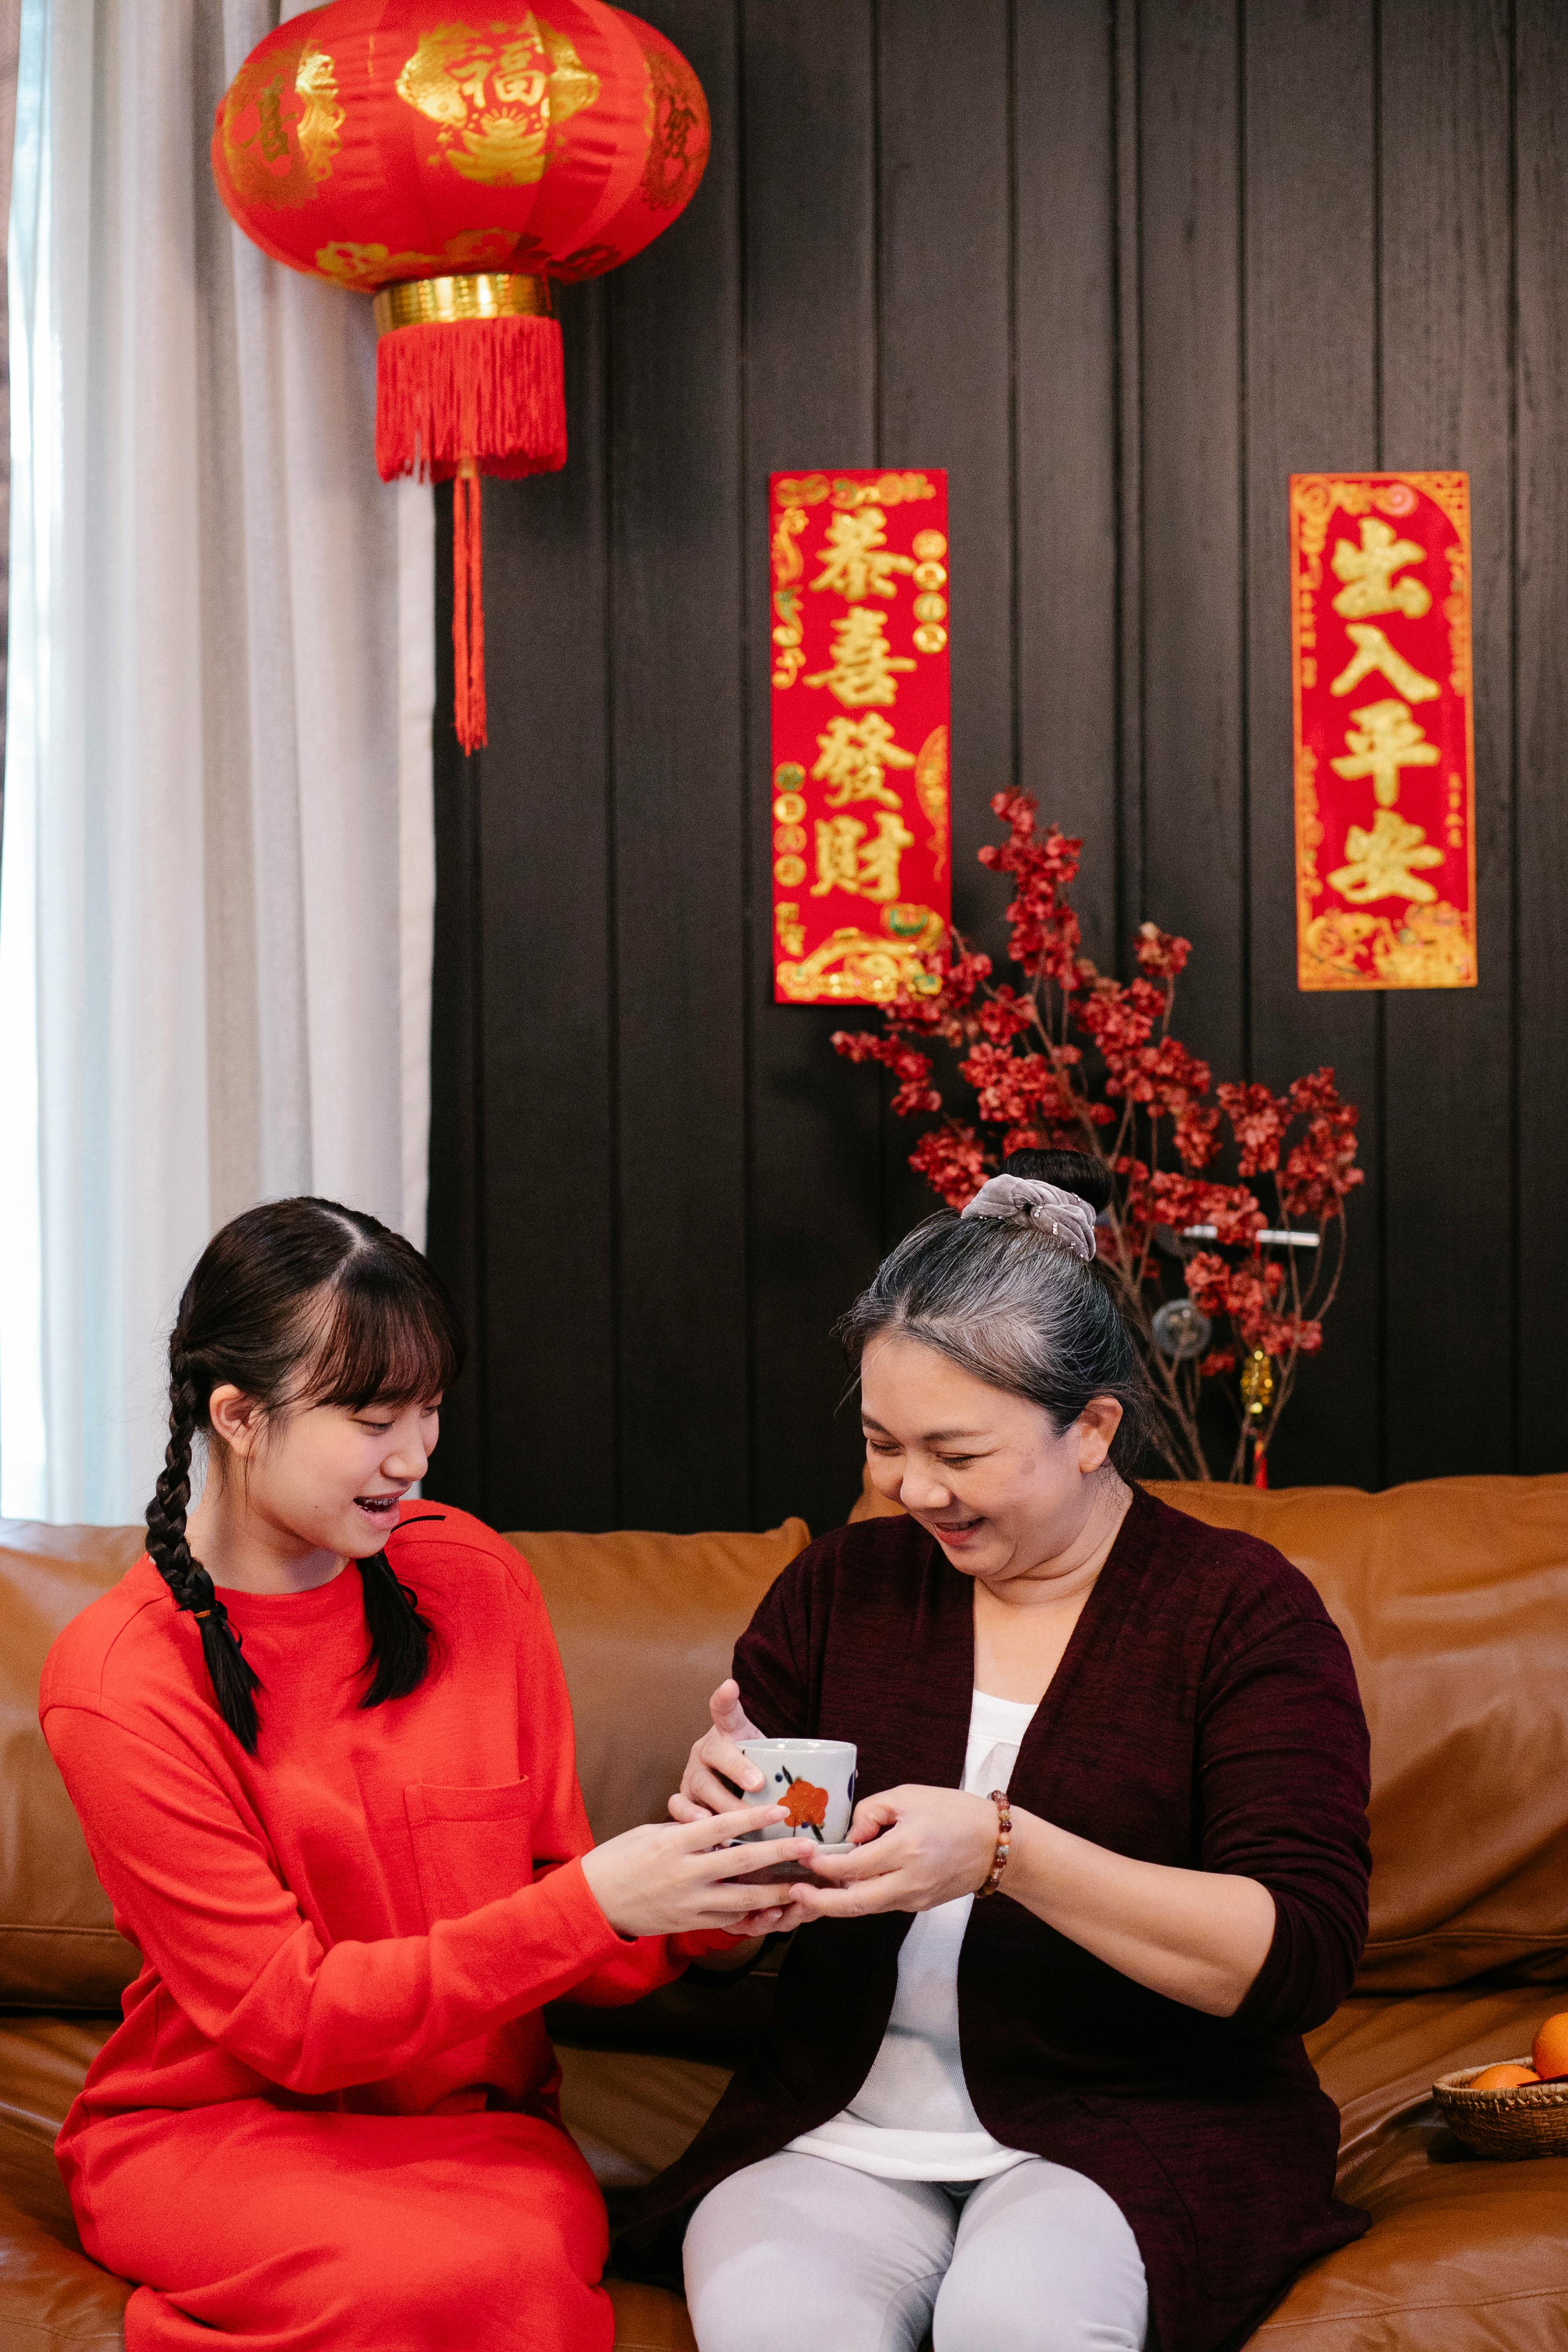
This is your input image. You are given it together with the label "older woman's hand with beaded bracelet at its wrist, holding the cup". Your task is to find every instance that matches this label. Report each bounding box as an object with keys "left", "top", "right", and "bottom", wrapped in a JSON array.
[{"left": 795, "top": 1785, "right": 997, "bottom": 1919}]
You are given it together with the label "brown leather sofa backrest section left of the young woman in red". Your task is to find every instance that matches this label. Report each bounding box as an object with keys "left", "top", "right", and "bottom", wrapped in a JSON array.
[{"left": 0, "top": 1519, "right": 141, "bottom": 2011}]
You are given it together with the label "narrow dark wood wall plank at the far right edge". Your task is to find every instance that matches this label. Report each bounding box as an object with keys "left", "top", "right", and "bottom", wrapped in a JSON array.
[{"left": 1514, "top": 0, "right": 1568, "bottom": 1470}]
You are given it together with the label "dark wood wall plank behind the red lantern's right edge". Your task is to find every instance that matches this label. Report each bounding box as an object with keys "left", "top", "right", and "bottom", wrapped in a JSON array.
[{"left": 609, "top": 0, "right": 750, "bottom": 1531}]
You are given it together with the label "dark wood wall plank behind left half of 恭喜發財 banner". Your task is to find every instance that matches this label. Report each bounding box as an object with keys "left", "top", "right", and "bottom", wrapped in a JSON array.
[{"left": 741, "top": 0, "right": 882, "bottom": 1529}]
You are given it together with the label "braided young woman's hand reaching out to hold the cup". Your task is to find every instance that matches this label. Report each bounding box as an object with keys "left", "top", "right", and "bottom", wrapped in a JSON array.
[{"left": 583, "top": 1804, "right": 811, "bottom": 1936}]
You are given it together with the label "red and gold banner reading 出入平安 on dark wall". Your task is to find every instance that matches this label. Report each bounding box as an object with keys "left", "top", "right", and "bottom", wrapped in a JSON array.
[{"left": 1291, "top": 473, "right": 1477, "bottom": 988}]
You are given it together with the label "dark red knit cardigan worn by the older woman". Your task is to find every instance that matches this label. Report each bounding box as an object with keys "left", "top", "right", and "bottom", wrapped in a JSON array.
[{"left": 628, "top": 1491, "right": 1368, "bottom": 2352}]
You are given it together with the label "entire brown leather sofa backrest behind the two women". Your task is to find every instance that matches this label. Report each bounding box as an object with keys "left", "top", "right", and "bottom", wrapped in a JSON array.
[{"left": 0, "top": 1477, "right": 1568, "bottom": 2009}]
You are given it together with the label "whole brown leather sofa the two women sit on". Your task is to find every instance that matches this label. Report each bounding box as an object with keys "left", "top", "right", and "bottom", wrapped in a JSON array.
[{"left": 0, "top": 1477, "right": 1568, "bottom": 2352}]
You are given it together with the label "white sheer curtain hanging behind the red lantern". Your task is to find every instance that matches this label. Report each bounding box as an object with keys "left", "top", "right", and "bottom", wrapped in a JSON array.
[{"left": 0, "top": 0, "right": 435, "bottom": 1522}]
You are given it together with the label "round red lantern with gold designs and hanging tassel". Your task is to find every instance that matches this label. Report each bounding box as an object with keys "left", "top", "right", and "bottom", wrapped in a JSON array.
[{"left": 211, "top": 0, "right": 707, "bottom": 750}]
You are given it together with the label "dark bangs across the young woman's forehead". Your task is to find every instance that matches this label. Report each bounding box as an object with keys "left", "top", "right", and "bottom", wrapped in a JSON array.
[{"left": 301, "top": 1237, "right": 465, "bottom": 1411}]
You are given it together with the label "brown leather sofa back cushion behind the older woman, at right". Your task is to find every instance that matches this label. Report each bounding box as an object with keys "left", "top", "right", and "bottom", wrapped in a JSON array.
[{"left": 851, "top": 1477, "right": 1568, "bottom": 1992}]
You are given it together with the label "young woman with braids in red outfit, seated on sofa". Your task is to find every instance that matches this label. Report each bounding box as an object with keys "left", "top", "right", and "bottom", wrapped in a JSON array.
[{"left": 40, "top": 1199, "right": 804, "bottom": 2352}]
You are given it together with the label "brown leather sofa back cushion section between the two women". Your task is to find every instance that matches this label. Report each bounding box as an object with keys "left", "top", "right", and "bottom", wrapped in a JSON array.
[{"left": 505, "top": 1519, "right": 811, "bottom": 1839}]
